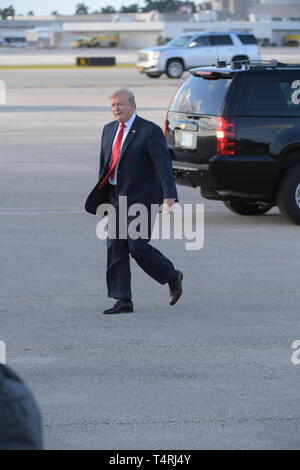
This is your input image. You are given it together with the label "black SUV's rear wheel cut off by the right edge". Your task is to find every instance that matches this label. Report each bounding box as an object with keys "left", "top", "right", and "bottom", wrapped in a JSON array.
[{"left": 277, "top": 163, "right": 300, "bottom": 225}]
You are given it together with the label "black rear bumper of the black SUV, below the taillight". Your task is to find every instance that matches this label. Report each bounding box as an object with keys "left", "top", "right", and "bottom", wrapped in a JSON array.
[{"left": 172, "top": 156, "right": 280, "bottom": 199}]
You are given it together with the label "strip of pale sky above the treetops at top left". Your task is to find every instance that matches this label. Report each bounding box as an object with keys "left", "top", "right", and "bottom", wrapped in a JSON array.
[{"left": 0, "top": 0, "right": 144, "bottom": 15}]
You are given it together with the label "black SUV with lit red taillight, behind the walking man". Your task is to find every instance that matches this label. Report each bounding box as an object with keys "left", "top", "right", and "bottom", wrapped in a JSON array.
[{"left": 165, "top": 61, "right": 300, "bottom": 224}]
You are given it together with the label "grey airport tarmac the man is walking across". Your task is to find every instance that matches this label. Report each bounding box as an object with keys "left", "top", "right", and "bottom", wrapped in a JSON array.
[{"left": 0, "top": 65, "right": 300, "bottom": 450}]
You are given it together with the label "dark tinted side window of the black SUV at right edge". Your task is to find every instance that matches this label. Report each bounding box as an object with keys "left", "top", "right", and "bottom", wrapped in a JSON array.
[{"left": 239, "top": 77, "right": 300, "bottom": 116}]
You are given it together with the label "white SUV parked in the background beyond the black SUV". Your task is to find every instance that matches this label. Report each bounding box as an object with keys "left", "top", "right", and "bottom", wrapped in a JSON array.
[{"left": 136, "top": 31, "right": 261, "bottom": 78}]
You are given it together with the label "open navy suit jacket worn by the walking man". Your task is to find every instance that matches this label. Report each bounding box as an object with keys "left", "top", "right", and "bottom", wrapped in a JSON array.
[{"left": 85, "top": 116, "right": 178, "bottom": 214}]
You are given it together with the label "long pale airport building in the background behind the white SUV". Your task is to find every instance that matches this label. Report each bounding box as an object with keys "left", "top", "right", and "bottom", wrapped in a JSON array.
[{"left": 0, "top": 0, "right": 300, "bottom": 49}]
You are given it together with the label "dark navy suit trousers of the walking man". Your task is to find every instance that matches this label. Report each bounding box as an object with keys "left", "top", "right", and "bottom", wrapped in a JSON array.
[{"left": 106, "top": 184, "right": 177, "bottom": 299}]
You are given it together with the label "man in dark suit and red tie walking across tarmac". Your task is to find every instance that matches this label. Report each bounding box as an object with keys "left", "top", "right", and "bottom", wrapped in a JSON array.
[{"left": 85, "top": 89, "right": 183, "bottom": 314}]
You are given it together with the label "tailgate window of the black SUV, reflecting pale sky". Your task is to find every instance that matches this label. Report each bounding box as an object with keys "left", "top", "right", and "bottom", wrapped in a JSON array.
[{"left": 170, "top": 75, "right": 232, "bottom": 116}]
